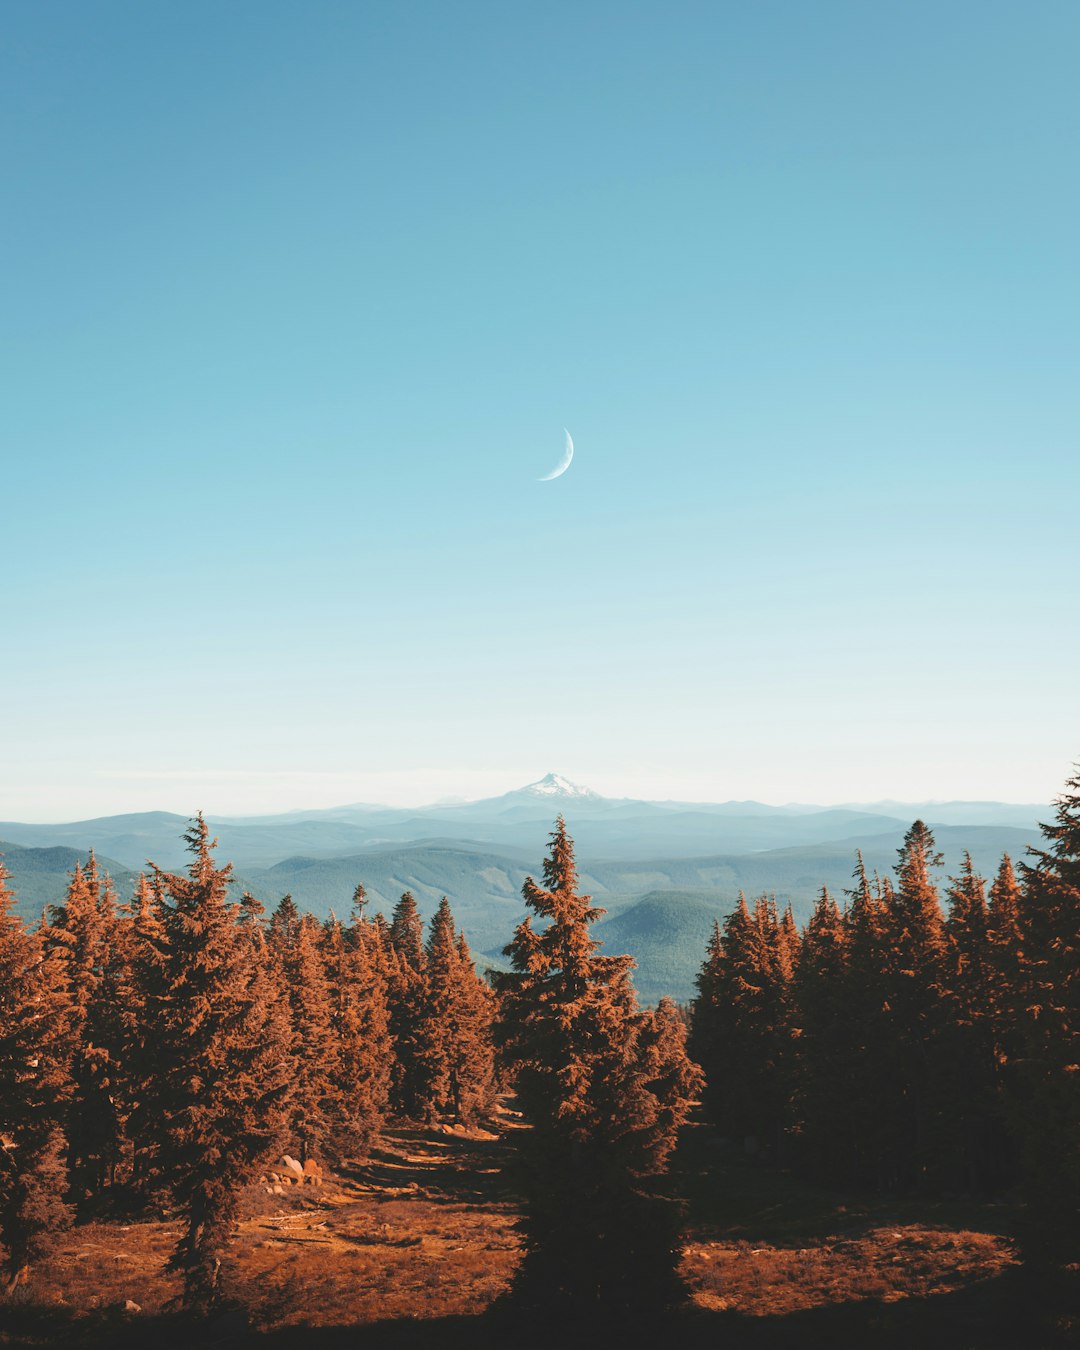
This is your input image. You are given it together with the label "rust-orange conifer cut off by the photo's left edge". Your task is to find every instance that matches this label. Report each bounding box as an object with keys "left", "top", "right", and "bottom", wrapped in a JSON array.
[{"left": 0, "top": 860, "right": 72, "bottom": 1289}]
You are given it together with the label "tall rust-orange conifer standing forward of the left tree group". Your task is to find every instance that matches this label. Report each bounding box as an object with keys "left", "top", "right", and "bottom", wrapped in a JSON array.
[{"left": 151, "top": 815, "right": 289, "bottom": 1308}]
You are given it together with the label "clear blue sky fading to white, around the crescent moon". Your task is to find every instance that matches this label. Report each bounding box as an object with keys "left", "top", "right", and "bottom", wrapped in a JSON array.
[{"left": 0, "top": 0, "right": 1080, "bottom": 819}]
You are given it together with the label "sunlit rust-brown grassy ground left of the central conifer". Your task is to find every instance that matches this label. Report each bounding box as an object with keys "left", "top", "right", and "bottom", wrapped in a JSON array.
[{"left": 0, "top": 1130, "right": 517, "bottom": 1345}]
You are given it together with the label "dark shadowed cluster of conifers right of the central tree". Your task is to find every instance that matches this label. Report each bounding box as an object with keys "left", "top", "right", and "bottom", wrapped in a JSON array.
[{"left": 690, "top": 778, "right": 1080, "bottom": 1330}]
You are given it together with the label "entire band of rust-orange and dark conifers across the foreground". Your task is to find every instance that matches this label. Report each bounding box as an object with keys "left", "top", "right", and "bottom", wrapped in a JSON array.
[{"left": 0, "top": 778, "right": 1080, "bottom": 1328}]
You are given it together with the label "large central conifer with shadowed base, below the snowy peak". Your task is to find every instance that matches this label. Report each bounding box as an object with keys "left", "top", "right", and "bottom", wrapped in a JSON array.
[{"left": 500, "top": 817, "right": 698, "bottom": 1315}]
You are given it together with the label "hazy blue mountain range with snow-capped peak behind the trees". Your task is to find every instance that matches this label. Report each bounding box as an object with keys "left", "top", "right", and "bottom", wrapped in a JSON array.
[{"left": 0, "top": 774, "right": 1052, "bottom": 999}]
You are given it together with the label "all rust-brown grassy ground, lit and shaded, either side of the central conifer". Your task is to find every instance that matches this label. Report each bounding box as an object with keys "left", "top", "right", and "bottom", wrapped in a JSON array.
[{"left": 0, "top": 1114, "right": 1038, "bottom": 1350}]
